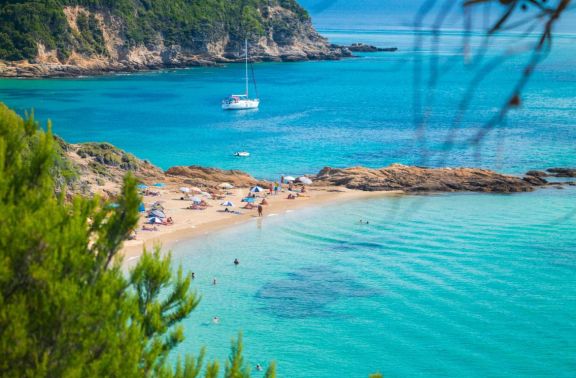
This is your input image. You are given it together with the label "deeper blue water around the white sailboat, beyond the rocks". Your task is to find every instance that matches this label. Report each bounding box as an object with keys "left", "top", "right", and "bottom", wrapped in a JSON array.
[{"left": 0, "top": 30, "right": 576, "bottom": 178}]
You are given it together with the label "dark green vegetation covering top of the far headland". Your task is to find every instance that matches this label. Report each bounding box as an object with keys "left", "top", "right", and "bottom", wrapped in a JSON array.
[{"left": 0, "top": 0, "right": 309, "bottom": 61}]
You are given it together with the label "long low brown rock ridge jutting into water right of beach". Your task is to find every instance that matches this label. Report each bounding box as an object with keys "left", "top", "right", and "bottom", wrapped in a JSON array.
[{"left": 315, "top": 164, "right": 539, "bottom": 193}]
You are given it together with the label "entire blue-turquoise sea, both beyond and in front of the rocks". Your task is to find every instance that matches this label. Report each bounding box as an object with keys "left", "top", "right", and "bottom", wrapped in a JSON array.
[{"left": 0, "top": 5, "right": 576, "bottom": 378}]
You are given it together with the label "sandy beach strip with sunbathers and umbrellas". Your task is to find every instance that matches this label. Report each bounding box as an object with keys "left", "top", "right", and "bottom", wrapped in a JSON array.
[{"left": 122, "top": 187, "right": 401, "bottom": 261}]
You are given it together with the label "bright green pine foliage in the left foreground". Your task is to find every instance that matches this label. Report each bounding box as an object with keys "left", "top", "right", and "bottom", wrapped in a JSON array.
[{"left": 0, "top": 104, "right": 274, "bottom": 377}]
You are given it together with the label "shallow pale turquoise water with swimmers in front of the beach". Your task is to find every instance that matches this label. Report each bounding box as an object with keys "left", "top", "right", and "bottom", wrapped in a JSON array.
[{"left": 174, "top": 189, "right": 576, "bottom": 377}]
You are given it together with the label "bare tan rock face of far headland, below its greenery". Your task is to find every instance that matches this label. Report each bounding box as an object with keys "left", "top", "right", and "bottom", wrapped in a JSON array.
[{"left": 0, "top": 6, "right": 352, "bottom": 77}]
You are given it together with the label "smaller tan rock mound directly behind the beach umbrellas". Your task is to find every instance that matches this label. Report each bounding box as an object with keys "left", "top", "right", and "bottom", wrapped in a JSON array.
[{"left": 166, "top": 165, "right": 268, "bottom": 188}]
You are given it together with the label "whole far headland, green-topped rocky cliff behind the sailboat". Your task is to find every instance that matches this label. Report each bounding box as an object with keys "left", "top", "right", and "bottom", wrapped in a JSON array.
[{"left": 0, "top": 0, "right": 351, "bottom": 77}]
